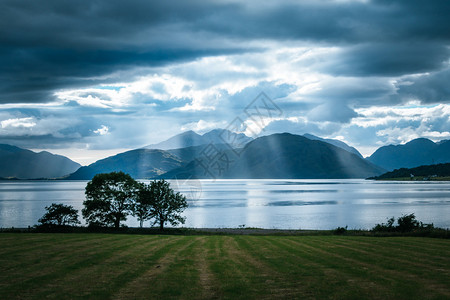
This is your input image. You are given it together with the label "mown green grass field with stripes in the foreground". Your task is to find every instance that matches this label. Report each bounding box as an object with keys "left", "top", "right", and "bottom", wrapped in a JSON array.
[{"left": 0, "top": 233, "right": 450, "bottom": 299}]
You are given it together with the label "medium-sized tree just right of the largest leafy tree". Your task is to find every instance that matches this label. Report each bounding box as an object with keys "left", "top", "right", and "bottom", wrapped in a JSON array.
[{"left": 143, "top": 179, "right": 188, "bottom": 230}]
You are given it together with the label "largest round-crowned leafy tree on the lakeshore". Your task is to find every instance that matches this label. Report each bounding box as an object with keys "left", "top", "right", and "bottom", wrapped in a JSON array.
[{"left": 82, "top": 172, "right": 138, "bottom": 228}]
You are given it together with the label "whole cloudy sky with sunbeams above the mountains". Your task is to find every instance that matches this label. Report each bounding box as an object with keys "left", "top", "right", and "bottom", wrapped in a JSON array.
[{"left": 0, "top": 0, "right": 450, "bottom": 164}]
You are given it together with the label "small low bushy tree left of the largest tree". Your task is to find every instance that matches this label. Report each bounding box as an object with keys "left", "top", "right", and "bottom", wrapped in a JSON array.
[{"left": 38, "top": 203, "right": 80, "bottom": 226}]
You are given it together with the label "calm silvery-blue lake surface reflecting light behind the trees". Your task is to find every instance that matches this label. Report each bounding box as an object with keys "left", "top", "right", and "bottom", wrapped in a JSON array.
[{"left": 0, "top": 180, "right": 450, "bottom": 229}]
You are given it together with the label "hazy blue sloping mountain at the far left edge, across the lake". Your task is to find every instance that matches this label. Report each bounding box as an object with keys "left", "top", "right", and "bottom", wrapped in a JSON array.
[{"left": 0, "top": 144, "right": 81, "bottom": 179}]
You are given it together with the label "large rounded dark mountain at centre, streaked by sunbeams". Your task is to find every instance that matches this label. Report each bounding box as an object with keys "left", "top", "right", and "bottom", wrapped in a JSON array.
[{"left": 161, "top": 133, "right": 384, "bottom": 178}]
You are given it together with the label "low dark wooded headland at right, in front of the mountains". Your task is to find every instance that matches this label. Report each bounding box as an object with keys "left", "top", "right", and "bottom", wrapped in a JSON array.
[{"left": 369, "top": 163, "right": 450, "bottom": 180}]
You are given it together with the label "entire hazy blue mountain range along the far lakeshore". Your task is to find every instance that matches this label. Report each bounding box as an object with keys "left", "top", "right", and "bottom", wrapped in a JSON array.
[{"left": 0, "top": 129, "right": 450, "bottom": 180}]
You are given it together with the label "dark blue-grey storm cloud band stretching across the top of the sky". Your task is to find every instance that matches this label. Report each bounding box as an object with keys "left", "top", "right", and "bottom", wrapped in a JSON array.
[{"left": 0, "top": 0, "right": 450, "bottom": 103}]
